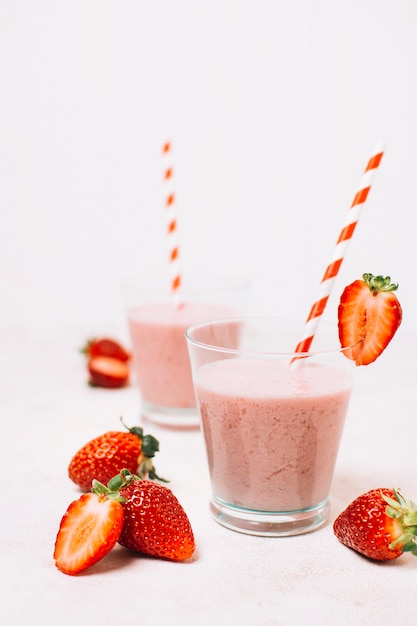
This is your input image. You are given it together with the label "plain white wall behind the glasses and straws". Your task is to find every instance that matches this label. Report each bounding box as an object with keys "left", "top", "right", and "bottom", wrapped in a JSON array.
[{"left": 0, "top": 0, "right": 417, "bottom": 332}]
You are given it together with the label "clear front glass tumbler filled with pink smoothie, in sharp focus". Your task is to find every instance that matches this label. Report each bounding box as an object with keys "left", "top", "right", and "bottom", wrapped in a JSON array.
[{"left": 186, "top": 317, "right": 355, "bottom": 536}]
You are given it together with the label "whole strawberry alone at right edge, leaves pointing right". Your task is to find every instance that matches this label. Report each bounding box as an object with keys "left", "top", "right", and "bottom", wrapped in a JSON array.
[{"left": 333, "top": 488, "right": 417, "bottom": 561}]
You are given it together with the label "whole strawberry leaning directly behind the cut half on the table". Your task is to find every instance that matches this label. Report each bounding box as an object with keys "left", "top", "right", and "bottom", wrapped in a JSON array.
[{"left": 119, "top": 476, "right": 195, "bottom": 561}]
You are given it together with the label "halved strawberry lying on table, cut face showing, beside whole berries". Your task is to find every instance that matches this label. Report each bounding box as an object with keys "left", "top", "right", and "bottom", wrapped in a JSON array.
[{"left": 54, "top": 493, "right": 124, "bottom": 575}]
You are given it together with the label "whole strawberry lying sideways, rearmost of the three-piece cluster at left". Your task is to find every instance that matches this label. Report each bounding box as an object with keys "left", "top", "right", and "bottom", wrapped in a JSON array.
[{"left": 68, "top": 416, "right": 163, "bottom": 491}]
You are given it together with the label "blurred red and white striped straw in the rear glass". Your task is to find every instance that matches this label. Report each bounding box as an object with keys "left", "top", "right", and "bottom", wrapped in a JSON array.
[{"left": 162, "top": 141, "right": 181, "bottom": 307}]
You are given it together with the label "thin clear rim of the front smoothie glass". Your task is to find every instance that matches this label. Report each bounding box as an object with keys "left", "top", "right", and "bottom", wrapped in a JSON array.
[{"left": 185, "top": 315, "right": 362, "bottom": 360}]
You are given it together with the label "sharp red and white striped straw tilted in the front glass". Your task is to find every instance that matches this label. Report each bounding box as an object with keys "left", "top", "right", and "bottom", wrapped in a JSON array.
[{"left": 295, "top": 144, "right": 384, "bottom": 352}]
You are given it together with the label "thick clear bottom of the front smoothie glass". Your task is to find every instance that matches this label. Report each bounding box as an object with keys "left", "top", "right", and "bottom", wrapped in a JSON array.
[{"left": 210, "top": 497, "right": 330, "bottom": 537}]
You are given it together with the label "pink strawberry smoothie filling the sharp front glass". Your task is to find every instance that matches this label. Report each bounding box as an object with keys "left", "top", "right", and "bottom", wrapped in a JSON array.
[{"left": 195, "top": 358, "right": 352, "bottom": 512}]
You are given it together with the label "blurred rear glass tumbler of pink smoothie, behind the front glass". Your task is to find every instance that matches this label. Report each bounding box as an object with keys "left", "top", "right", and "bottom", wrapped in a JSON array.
[{"left": 123, "top": 275, "right": 248, "bottom": 428}]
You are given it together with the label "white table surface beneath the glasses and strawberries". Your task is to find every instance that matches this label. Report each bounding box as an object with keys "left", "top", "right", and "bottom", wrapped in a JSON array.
[{"left": 0, "top": 328, "right": 417, "bottom": 626}]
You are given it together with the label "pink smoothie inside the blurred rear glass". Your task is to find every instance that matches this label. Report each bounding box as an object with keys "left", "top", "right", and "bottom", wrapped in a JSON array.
[{"left": 128, "top": 302, "right": 236, "bottom": 408}]
